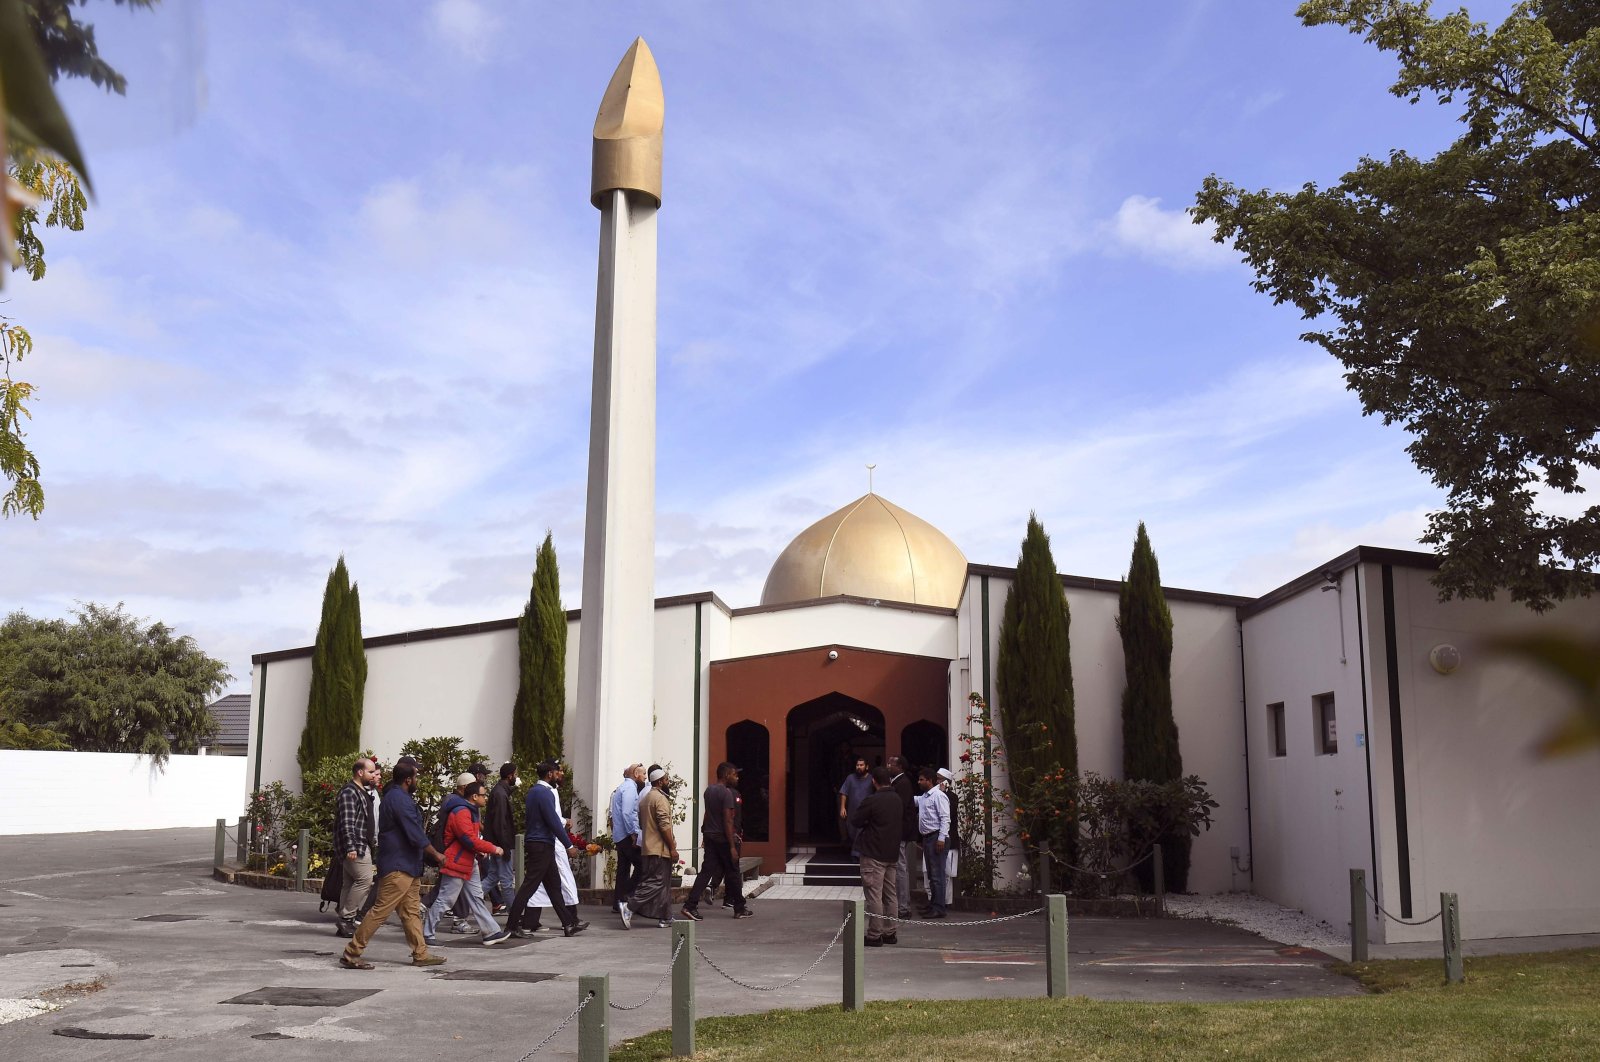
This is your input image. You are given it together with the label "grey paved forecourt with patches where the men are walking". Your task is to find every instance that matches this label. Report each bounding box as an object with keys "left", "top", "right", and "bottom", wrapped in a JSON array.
[{"left": 0, "top": 830, "right": 1360, "bottom": 1062}]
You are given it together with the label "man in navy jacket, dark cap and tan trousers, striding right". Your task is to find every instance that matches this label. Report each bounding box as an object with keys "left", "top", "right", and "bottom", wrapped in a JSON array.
[{"left": 339, "top": 763, "right": 445, "bottom": 969}]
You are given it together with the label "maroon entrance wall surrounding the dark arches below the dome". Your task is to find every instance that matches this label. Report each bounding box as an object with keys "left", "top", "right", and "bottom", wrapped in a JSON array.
[{"left": 709, "top": 645, "right": 950, "bottom": 873}]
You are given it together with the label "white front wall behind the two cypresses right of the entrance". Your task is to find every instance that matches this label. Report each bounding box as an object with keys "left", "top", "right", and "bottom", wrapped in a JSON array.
[{"left": 952, "top": 574, "right": 1250, "bottom": 892}]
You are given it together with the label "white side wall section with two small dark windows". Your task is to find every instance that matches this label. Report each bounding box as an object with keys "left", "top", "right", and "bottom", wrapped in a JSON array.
[{"left": 1243, "top": 571, "right": 1382, "bottom": 940}]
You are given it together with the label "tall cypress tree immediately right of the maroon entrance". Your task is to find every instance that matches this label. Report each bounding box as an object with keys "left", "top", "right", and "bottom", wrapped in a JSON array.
[{"left": 995, "top": 513, "right": 1078, "bottom": 859}]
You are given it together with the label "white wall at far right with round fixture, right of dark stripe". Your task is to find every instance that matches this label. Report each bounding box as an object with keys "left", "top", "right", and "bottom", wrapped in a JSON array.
[{"left": 1352, "top": 565, "right": 1600, "bottom": 940}]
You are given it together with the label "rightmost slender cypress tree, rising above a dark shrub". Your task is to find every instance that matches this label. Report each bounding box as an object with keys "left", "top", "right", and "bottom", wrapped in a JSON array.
[{"left": 1117, "top": 521, "right": 1192, "bottom": 892}]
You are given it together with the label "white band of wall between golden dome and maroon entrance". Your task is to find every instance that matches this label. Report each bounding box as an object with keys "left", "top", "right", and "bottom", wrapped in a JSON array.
[{"left": 732, "top": 601, "right": 955, "bottom": 659}]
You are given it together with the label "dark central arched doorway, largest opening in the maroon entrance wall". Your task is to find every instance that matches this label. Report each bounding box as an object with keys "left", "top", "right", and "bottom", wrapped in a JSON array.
[{"left": 784, "top": 691, "right": 883, "bottom": 844}]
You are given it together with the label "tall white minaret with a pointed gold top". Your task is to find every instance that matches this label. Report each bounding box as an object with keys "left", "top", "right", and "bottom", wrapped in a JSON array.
[{"left": 573, "top": 37, "right": 664, "bottom": 828}]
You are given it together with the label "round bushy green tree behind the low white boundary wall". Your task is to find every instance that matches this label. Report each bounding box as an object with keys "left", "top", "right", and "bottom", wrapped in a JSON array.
[{"left": 0, "top": 603, "right": 230, "bottom": 765}]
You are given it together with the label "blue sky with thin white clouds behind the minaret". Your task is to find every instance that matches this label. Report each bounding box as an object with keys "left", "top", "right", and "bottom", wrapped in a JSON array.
[{"left": 0, "top": 0, "right": 1504, "bottom": 689}]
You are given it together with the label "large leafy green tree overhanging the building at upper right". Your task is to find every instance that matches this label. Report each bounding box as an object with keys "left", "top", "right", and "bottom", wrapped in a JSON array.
[{"left": 1195, "top": 0, "right": 1600, "bottom": 609}]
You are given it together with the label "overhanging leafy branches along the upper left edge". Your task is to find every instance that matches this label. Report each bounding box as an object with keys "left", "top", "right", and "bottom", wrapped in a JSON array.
[{"left": 0, "top": 0, "right": 155, "bottom": 520}]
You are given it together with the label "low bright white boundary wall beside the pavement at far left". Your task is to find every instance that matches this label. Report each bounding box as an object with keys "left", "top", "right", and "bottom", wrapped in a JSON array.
[{"left": 0, "top": 750, "right": 246, "bottom": 835}]
